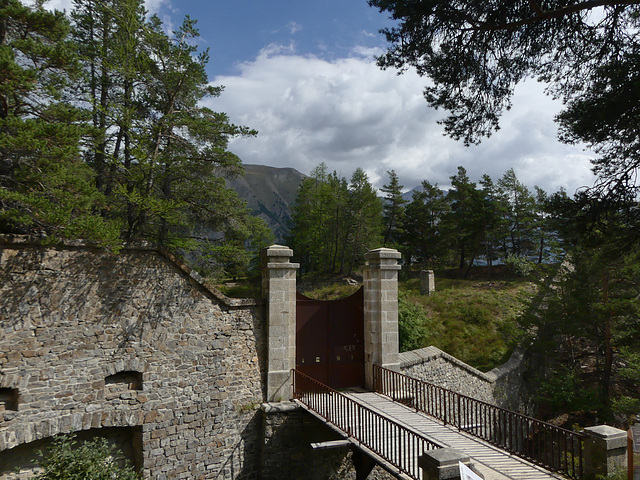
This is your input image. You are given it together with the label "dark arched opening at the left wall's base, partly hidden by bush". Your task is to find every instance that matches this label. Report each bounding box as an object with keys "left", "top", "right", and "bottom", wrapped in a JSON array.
[{"left": 0, "top": 427, "right": 143, "bottom": 480}]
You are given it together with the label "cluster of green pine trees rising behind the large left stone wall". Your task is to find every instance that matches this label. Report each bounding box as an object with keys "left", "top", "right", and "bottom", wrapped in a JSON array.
[{"left": 0, "top": 0, "right": 269, "bottom": 273}]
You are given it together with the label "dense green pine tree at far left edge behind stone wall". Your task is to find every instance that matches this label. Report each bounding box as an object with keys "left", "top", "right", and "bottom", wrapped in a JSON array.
[{"left": 0, "top": 0, "right": 118, "bottom": 245}]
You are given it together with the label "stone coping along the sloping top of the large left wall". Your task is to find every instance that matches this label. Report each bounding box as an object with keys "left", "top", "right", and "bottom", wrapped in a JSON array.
[{"left": 0, "top": 234, "right": 258, "bottom": 308}]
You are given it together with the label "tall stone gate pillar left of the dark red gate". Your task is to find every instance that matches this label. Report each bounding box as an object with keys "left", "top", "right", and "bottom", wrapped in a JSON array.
[{"left": 262, "top": 245, "right": 300, "bottom": 402}]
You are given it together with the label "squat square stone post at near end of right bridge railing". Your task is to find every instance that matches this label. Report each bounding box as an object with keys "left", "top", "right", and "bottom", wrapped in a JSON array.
[{"left": 584, "top": 425, "right": 627, "bottom": 479}]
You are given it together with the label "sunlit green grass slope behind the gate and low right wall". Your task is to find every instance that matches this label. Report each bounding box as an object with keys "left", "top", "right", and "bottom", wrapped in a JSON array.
[{"left": 218, "top": 268, "right": 535, "bottom": 371}]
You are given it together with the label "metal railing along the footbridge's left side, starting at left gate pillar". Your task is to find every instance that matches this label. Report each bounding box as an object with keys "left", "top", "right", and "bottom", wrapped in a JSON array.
[{"left": 293, "top": 370, "right": 442, "bottom": 480}]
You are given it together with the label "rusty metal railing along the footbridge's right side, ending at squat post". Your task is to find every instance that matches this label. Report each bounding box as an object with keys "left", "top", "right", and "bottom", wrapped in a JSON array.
[{"left": 373, "top": 365, "right": 585, "bottom": 479}]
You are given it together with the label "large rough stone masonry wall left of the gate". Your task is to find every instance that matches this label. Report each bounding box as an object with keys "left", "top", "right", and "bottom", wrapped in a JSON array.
[{"left": 0, "top": 236, "right": 265, "bottom": 480}]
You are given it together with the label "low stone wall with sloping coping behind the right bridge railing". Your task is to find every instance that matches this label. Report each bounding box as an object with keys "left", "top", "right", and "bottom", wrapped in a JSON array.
[{"left": 400, "top": 346, "right": 524, "bottom": 410}]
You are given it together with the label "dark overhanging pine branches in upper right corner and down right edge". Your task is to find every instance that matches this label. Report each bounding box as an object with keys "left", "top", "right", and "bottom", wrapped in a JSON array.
[{"left": 369, "top": 0, "right": 640, "bottom": 253}]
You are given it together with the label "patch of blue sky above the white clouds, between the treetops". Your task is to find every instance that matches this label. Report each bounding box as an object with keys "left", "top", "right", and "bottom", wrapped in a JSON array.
[{"left": 168, "top": 0, "right": 390, "bottom": 77}]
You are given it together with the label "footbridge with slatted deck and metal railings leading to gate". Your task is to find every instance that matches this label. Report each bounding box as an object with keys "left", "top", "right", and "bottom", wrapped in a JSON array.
[{"left": 293, "top": 366, "right": 586, "bottom": 480}]
